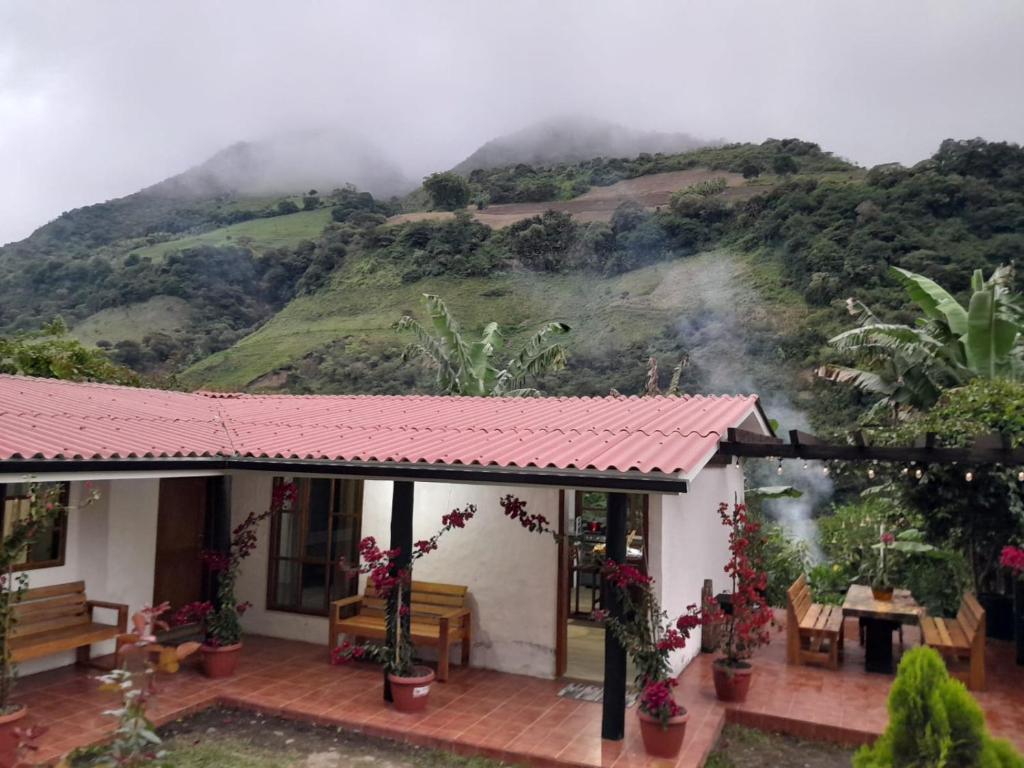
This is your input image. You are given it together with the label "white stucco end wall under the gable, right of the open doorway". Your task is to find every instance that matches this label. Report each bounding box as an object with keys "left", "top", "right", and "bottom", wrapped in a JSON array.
[{"left": 648, "top": 467, "right": 743, "bottom": 673}]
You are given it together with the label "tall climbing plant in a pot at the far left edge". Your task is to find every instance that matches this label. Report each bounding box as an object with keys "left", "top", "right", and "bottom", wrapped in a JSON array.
[{"left": 0, "top": 483, "right": 99, "bottom": 728}]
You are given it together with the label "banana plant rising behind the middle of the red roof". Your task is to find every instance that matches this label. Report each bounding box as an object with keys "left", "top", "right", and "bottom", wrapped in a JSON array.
[{"left": 396, "top": 294, "right": 570, "bottom": 397}]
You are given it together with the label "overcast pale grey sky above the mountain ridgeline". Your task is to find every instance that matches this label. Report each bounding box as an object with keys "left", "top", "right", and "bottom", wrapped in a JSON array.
[{"left": 0, "top": 0, "right": 1024, "bottom": 243}]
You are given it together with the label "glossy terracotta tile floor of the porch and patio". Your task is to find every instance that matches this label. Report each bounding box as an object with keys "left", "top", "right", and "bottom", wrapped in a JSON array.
[{"left": 16, "top": 622, "right": 1024, "bottom": 768}]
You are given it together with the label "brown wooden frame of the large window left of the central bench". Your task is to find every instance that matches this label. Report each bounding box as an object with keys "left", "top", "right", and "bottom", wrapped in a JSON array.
[{"left": 266, "top": 477, "right": 365, "bottom": 616}]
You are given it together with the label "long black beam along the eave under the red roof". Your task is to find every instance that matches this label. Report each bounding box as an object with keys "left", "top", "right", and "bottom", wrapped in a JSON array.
[{"left": 0, "top": 456, "right": 687, "bottom": 494}]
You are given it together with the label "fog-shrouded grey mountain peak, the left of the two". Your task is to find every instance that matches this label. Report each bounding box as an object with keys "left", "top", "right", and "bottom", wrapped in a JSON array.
[{"left": 149, "top": 130, "right": 416, "bottom": 198}]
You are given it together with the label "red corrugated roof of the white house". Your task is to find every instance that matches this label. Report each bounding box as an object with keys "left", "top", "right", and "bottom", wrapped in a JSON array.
[{"left": 0, "top": 376, "right": 757, "bottom": 477}]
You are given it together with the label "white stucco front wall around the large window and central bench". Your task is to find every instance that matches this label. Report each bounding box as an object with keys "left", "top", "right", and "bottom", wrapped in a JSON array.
[{"left": 231, "top": 473, "right": 558, "bottom": 677}]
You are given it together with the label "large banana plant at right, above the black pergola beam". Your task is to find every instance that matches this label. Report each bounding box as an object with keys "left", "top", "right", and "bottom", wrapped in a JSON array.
[{"left": 818, "top": 266, "right": 1024, "bottom": 421}]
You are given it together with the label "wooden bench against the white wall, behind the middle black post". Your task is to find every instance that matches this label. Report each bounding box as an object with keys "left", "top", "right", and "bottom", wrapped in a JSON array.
[{"left": 328, "top": 581, "right": 472, "bottom": 681}]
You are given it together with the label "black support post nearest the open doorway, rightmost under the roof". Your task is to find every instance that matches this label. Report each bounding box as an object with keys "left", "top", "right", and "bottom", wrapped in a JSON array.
[{"left": 601, "top": 494, "right": 629, "bottom": 741}]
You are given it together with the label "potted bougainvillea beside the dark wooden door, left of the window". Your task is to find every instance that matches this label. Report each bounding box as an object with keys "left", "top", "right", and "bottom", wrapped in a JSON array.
[{"left": 174, "top": 483, "right": 295, "bottom": 678}]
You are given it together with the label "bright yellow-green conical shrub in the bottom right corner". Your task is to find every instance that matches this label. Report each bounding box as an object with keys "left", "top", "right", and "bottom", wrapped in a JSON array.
[{"left": 853, "top": 646, "right": 1024, "bottom": 768}]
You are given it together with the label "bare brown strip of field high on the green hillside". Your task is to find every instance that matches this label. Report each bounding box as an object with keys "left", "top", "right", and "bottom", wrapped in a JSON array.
[{"left": 388, "top": 168, "right": 764, "bottom": 229}]
